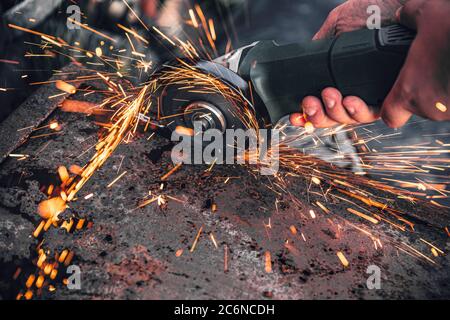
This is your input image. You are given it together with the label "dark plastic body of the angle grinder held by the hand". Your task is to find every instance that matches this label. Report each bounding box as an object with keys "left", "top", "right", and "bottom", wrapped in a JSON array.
[{"left": 238, "top": 25, "right": 415, "bottom": 124}]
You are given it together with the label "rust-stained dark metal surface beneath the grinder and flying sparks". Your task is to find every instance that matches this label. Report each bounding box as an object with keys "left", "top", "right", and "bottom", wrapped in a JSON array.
[{"left": 0, "top": 65, "right": 450, "bottom": 299}]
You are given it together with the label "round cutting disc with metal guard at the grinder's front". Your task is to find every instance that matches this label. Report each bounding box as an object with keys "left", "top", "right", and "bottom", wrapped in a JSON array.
[{"left": 154, "top": 60, "right": 268, "bottom": 133}]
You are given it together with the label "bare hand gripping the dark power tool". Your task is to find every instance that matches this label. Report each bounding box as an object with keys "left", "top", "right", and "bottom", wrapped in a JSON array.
[{"left": 291, "top": 0, "right": 450, "bottom": 128}]
